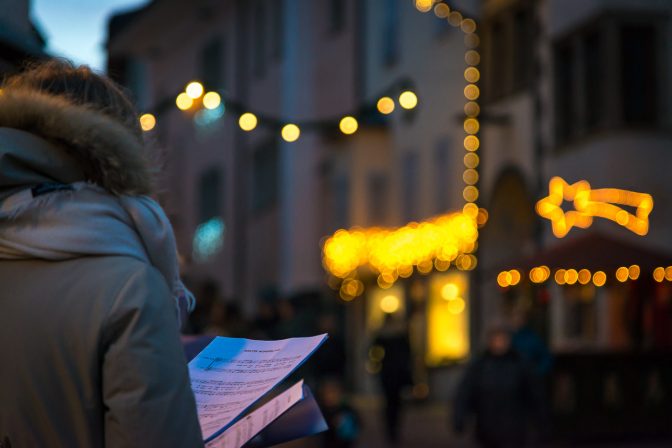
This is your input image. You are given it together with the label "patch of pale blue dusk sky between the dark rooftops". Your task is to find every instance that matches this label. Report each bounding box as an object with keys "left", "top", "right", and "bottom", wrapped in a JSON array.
[{"left": 31, "top": 0, "right": 149, "bottom": 70}]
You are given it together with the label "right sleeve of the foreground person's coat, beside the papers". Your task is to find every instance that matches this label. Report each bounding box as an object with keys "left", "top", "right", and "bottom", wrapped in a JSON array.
[{"left": 102, "top": 265, "right": 203, "bottom": 447}]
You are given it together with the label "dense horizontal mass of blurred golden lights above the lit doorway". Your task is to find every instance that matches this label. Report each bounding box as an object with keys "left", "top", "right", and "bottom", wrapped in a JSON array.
[{"left": 323, "top": 212, "right": 478, "bottom": 285}]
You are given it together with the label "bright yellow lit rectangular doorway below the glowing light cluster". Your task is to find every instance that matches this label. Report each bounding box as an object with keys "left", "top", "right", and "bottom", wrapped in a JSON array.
[{"left": 425, "top": 271, "right": 470, "bottom": 366}]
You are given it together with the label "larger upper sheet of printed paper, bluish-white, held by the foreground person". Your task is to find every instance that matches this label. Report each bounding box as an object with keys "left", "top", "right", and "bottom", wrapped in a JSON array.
[{"left": 189, "top": 334, "right": 327, "bottom": 441}]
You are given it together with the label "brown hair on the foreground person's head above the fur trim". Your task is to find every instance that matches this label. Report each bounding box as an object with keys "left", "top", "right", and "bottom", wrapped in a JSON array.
[{"left": 3, "top": 58, "right": 142, "bottom": 142}]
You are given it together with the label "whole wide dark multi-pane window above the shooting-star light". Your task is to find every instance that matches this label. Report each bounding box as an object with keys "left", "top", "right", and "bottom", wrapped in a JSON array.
[{"left": 554, "top": 14, "right": 665, "bottom": 144}]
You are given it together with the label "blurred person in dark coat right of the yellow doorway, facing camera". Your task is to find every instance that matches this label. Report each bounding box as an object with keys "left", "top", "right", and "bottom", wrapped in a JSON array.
[{"left": 453, "top": 326, "right": 540, "bottom": 448}]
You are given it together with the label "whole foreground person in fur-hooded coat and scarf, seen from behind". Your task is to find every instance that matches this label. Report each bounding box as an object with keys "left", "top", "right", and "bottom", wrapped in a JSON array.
[{"left": 0, "top": 60, "right": 203, "bottom": 447}]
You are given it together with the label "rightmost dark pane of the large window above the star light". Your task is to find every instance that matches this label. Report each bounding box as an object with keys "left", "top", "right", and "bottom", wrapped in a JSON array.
[{"left": 620, "top": 25, "right": 658, "bottom": 125}]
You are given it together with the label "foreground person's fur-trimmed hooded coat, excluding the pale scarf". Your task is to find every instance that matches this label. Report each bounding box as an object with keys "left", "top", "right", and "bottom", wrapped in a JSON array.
[{"left": 0, "top": 90, "right": 203, "bottom": 447}]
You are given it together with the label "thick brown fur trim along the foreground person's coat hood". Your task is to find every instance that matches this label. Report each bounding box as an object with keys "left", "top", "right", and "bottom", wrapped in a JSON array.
[{"left": 0, "top": 88, "right": 153, "bottom": 195}]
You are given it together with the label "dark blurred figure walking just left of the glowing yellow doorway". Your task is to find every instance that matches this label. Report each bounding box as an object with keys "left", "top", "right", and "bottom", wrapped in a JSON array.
[{"left": 373, "top": 314, "right": 412, "bottom": 445}]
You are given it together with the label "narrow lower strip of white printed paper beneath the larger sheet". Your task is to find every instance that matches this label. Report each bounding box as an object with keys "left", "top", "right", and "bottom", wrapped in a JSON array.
[{"left": 206, "top": 380, "right": 303, "bottom": 448}]
